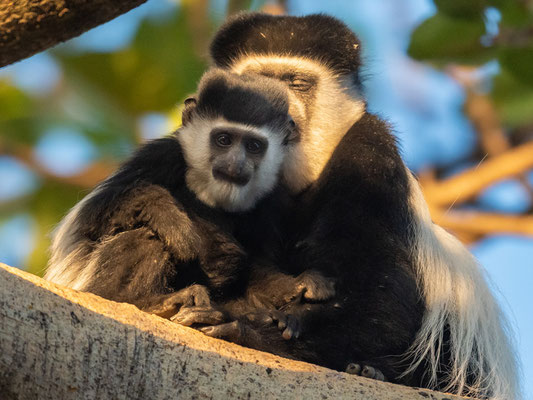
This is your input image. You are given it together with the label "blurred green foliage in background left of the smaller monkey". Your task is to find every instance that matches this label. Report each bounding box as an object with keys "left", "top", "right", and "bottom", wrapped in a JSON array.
[{"left": 0, "top": 1, "right": 214, "bottom": 275}]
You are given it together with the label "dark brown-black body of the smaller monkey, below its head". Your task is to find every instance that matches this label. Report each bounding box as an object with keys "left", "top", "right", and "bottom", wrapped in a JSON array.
[{"left": 71, "top": 138, "right": 290, "bottom": 309}]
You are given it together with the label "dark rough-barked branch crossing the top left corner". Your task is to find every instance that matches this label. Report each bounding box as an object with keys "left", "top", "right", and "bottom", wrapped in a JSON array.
[{"left": 0, "top": 0, "right": 146, "bottom": 67}]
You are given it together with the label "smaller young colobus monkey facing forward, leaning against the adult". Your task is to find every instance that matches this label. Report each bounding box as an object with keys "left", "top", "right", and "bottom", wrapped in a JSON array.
[{"left": 45, "top": 69, "right": 333, "bottom": 324}]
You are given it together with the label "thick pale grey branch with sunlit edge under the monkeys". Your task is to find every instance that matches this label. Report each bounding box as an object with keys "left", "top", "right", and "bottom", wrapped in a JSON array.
[{"left": 0, "top": 264, "right": 466, "bottom": 400}]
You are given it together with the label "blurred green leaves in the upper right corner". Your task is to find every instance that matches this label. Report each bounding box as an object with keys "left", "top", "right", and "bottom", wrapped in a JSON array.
[{"left": 409, "top": 0, "right": 533, "bottom": 127}]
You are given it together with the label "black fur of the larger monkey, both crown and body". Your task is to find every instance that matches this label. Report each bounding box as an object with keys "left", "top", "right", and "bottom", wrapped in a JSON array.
[{"left": 206, "top": 14, "right": 424, "bottom": 384}]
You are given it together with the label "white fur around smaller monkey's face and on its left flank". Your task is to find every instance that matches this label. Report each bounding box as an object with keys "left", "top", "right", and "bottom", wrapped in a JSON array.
[{"left": 44, "top": 118, "right": 285, "bottom": 290}]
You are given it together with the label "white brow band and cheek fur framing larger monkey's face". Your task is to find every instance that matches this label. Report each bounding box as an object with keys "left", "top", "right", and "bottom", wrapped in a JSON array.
[{"left": 232, "top": 54, "right": 365, "bottom": 192}]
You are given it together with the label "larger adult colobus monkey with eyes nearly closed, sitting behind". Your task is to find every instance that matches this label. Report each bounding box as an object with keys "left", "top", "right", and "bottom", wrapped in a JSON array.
[{"left": 207, "top": 14, "right": 518, "bottom": 400}]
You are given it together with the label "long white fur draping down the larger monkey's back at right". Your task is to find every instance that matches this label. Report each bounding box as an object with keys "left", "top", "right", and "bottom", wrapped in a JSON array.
[{"left": 406, "top": 171, "right": 519, "bottom": 400}]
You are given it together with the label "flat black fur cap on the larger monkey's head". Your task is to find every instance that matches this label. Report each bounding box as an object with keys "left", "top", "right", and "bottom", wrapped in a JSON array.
[{"left": 211, "top": 13, "right": 361, "bottom": 84}]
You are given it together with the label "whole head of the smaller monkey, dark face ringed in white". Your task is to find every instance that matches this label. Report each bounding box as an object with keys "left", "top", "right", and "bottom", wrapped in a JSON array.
[{"left": 177, "top": 69, "right": 299, "bottom": 211}]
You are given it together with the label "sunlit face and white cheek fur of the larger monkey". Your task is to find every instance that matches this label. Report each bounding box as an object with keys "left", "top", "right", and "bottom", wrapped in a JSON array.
[{"left": 231, "top": 55, "right": 365, "bottom": 192}]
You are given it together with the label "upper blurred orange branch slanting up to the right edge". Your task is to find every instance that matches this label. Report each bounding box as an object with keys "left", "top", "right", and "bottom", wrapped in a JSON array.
[{"left": 422, "top": 142, "right": 533, "bottom": 207}]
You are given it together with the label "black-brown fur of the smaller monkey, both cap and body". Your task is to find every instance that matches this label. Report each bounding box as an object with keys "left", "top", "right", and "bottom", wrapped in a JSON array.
[{"left": 47, "top": 70, "right": 330, "bottom": 323}]
